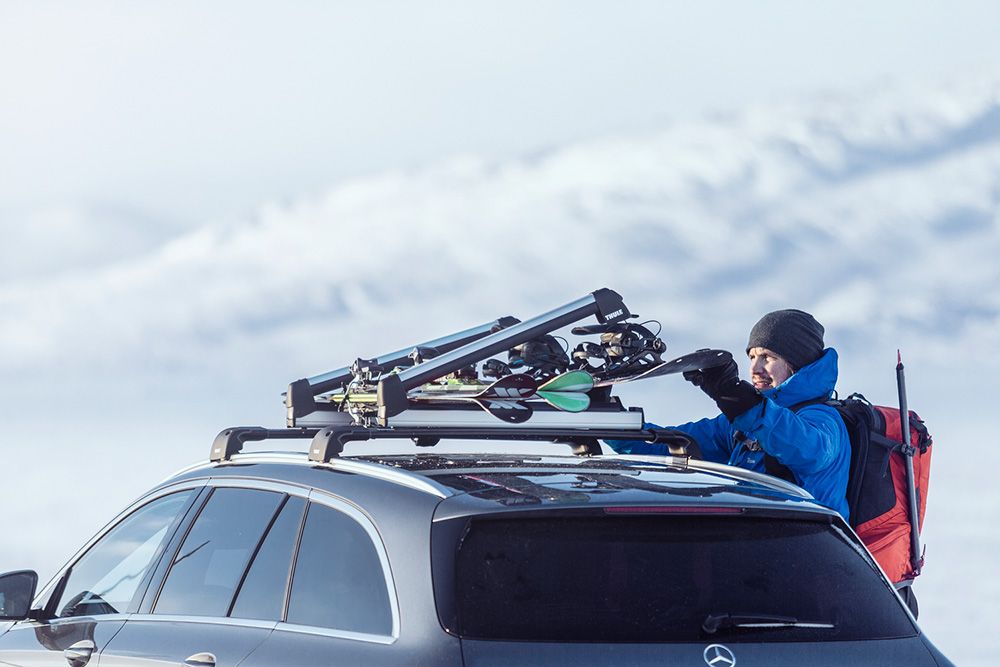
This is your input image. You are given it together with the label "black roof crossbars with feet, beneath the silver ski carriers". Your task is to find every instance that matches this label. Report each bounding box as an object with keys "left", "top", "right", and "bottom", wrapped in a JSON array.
[{"left": 209, "top": 424, "right": 701, "bottom": 463}]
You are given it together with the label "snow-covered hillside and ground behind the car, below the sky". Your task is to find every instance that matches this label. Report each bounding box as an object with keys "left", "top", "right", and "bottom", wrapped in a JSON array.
[{"left": 0, "top": 70, "right": 1000, "bottom": 664}]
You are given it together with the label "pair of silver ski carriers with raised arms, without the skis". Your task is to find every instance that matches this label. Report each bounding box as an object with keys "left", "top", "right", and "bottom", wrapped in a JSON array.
[{"left": 285, "top": 288, "right": 643, "bottom": 433}]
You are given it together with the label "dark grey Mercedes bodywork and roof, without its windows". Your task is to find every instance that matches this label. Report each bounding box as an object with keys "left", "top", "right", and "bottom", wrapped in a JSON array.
[{"left": 0, "top": 453, "right": 949, "bottom": 667}]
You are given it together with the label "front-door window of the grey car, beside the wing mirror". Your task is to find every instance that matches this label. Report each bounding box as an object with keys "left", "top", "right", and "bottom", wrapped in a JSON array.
[{"left": 56, "top": 491, "right": 193, "bottom": 618}]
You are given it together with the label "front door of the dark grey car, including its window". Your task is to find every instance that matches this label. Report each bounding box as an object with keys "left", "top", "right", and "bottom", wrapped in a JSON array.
[{"left": 0, "top": 488, "right": 197, "bottom": 667}]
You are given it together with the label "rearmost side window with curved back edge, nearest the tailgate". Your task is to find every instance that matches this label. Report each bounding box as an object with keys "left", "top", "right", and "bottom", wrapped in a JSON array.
[{"left": 287, "top": 503, "right": 392, "bottom": 636}]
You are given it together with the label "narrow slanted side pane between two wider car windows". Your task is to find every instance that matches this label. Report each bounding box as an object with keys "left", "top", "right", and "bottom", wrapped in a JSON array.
[{"left": 230, "top": 496, "right": 306, "bottom": 621}]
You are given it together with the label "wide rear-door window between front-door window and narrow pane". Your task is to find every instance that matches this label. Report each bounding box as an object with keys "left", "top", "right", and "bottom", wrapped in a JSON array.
[{"left": 153, "top": 488, "right": 285, "bottom": 616}]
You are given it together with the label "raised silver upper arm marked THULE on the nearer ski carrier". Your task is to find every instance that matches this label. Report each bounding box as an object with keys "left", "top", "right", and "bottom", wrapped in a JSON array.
[{"left": 376, "top": 287, "right": 632, "bottom": 426}]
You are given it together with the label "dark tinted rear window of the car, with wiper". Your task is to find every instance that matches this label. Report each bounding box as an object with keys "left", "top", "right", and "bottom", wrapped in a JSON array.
[{"left": 438, "top": 515, "right": 916, "bottom": 642}]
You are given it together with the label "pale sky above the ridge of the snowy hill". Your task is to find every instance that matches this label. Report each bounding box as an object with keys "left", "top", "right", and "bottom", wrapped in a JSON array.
[{"left": 0, "top": 0, "right": 1000, "bottom": 230}]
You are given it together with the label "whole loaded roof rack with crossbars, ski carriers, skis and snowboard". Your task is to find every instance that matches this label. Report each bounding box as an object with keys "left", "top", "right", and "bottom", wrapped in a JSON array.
[{"left": 256, "top": 288, "right": 729, "bottom": 461}]
